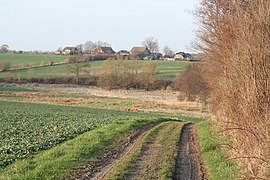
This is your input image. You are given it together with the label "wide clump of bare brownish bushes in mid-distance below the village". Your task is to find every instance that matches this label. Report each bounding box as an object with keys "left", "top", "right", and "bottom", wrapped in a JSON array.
[{"left": 98, "top": 60, "right": 157, "bottom": 90}]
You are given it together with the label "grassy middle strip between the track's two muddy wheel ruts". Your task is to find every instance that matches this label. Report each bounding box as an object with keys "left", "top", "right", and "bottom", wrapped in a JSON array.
[{"left": 126, "top": 123, "right": 182, "bottom": 180}]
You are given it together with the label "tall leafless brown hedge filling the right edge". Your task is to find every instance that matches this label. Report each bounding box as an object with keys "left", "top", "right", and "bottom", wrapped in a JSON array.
[{"left": 196, "top": 0, "right": 270, "bottom": 179}]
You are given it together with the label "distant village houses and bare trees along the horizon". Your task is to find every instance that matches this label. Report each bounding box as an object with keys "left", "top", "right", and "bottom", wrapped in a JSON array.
[{"left": 0, "top": 41, "right": 201, "bottom": 61}]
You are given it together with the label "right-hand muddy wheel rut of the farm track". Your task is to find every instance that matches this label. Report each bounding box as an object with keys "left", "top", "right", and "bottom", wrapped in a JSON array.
[{"left": 174, "top": 123, "right": 208, "bottom": 180}]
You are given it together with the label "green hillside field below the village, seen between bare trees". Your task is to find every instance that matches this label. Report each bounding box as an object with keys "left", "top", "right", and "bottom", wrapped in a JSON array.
[{"left": 0, "top": 61, "right": 191, "bottom": 79}]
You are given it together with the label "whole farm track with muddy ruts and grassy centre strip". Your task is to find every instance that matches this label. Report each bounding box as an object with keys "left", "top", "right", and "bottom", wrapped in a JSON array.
[{"left": 71, "top": 122, "right": 208, "bottom": 180}]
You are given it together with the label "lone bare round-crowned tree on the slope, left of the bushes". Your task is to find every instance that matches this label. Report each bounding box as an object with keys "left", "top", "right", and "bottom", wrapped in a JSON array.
[{"left": 66, "top": 55, "right": 91, "bottom": 84}]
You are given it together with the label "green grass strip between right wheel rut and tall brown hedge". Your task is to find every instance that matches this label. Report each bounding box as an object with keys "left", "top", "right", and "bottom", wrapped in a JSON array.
[{"left": 198, "top": 121, "right": 238, "bottom": 180}]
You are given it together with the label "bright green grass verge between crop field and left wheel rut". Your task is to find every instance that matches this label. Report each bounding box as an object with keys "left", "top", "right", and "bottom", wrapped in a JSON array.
[{"left": 0, "top": 119, "right": 163, "bottom": 180}]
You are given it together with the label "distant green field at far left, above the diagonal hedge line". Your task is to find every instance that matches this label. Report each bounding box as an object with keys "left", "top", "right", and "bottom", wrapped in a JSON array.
[{"left": 0, "top": 54, "right": 67, "bottom": 67}]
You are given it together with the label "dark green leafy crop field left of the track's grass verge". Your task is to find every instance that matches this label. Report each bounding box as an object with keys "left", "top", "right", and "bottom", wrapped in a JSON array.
[{"left": 0, "top": 101, "right": 160, "bottom": 168}]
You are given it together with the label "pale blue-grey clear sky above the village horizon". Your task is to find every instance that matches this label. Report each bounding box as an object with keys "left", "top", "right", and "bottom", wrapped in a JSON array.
[{"left": 0, "top": 0, "right": 197, "bottom": 51}]
